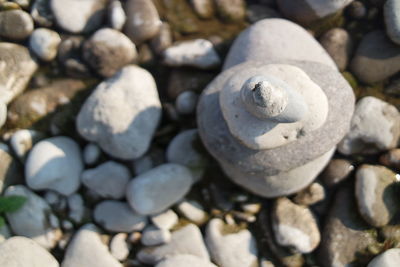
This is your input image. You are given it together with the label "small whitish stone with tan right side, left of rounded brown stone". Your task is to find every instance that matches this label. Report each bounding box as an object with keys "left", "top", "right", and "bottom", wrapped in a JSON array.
[{"left": 29, "top": 28, "right": 61, "bottom": 61}]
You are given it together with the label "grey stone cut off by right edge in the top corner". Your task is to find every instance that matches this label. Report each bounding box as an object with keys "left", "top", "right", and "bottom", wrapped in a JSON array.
[{"left": 383, "top": 0, "right": 400, "bottom": 44}]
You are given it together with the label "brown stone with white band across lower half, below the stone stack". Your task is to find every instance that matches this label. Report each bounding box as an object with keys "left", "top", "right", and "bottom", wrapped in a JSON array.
[{"left": 272, "top": 198, "right": 321, "bottom": 253}]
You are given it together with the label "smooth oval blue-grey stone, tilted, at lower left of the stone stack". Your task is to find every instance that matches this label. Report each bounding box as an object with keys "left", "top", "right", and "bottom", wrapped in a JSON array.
[{"left": 126, "top": 163, "right": 193, "bottom": 214}]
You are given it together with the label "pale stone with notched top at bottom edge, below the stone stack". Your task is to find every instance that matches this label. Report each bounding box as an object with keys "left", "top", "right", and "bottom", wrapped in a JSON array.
[{"left": 206, "top": 219, "right": 258, "bottom": 267}]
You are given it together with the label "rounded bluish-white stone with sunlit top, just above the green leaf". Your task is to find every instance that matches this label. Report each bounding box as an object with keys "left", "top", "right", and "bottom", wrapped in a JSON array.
[{"left": 25, "top": 136, "right": 83, "bottom": 196}]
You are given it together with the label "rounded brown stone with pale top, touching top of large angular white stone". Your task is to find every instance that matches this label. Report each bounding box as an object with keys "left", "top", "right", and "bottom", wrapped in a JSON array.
[{"left": 83, "top": 28, "right": 137, "bottom": 78}]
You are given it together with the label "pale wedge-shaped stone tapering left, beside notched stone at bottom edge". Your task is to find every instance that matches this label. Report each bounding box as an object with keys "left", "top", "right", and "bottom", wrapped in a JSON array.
[{"left": 137, "top": 224, "right": 210, "bottom": 265}]
